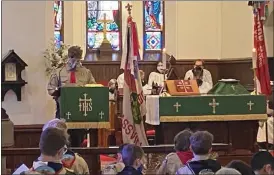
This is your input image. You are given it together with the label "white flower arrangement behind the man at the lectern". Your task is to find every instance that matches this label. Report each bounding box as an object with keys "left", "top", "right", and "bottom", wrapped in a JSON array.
[{"left": 43, "top": 40, "right": 69, "bottom": 76}]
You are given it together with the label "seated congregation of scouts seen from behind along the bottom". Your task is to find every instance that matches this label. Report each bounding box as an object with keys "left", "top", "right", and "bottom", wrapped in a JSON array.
[{"left": 15, "top": 119, "right": 274, "bottom": 175}]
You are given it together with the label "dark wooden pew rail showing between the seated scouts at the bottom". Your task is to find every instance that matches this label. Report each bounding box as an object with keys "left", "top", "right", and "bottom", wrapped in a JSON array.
[{"left": 2, "top": 143, "right": 255, "bottom": 175}]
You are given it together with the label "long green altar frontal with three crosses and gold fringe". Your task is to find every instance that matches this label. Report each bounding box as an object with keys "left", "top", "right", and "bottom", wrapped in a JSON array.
[{"left": 159, "top": 95, "right": 267, "bottom": 122}]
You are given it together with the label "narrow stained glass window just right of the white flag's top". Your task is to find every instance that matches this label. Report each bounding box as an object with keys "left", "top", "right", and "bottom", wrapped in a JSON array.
[{"left": 143, "top": 1, "right": 164, "bottom": 51}]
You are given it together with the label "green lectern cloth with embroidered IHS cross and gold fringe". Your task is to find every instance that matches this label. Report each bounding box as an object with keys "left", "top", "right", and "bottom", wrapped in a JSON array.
[{"left": 60, "top": 87, "right": 110, "bottom": 129}]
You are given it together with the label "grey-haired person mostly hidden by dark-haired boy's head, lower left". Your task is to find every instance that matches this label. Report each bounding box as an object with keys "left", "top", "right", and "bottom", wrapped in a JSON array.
[{"left": 43, "top": 119, "right": 89, "bottom": 174}]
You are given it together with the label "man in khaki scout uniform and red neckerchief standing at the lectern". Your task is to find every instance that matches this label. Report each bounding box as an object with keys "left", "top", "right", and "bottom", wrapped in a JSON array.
[{"left": 47, "top": 46, "right": 96, "bottom": 146}]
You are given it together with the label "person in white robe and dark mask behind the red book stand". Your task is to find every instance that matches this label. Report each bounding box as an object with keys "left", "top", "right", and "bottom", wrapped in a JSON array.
[{"left": 184, "top": 60, "right": 213, "bottom": 94}]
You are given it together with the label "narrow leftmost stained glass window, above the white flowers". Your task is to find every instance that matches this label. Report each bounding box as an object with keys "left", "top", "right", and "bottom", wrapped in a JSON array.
[{"left": 53, "top": 1, "right": 64, "bottom": 48}]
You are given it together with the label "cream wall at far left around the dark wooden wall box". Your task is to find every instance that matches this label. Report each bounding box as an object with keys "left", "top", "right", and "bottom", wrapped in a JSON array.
[{"left": 2, "top": 1, "right": 54, "bottom": 124}]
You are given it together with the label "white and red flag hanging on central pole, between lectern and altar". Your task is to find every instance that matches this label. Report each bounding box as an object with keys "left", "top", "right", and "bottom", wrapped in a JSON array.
[{"left": 121, "top": 17, "right": 148, "bottom": 146}]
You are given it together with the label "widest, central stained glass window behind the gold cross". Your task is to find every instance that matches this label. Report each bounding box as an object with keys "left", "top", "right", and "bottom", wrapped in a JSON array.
[{"left": 87, "top": 1, "right": 121, "bottom": 51}]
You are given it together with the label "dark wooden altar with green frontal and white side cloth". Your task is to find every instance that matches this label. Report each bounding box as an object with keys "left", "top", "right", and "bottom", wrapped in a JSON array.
[{"left": 145, "top": 95, "right": 267, "bottom": 151}]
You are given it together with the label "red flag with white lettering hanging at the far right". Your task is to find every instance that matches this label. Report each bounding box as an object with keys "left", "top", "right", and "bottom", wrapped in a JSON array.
[{"left": 254, "top": 8, "right": 271, "bottom": 95}]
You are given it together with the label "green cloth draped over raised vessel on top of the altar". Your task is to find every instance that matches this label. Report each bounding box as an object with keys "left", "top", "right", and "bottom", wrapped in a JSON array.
[{"left": 208, "top": 80, "right": 250, "bottom": 95}]
